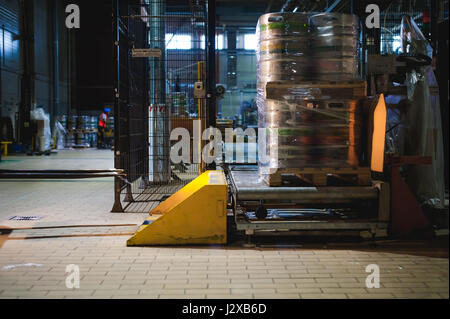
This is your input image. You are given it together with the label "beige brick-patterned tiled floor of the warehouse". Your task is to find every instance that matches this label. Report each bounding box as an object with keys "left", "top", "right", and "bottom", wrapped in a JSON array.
[{"left": 0, "top": 150, "right": 449, "bottom": 299}]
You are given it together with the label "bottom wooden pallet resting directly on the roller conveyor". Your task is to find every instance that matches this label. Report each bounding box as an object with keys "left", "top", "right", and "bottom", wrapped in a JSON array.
[{"left": 264, "top": 167, "right": 371, "bottom": 186}]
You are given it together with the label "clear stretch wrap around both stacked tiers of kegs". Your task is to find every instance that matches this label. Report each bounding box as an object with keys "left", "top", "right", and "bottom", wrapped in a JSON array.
[{"left": 257, "top": 13, "right": 361, "bottom": 175}]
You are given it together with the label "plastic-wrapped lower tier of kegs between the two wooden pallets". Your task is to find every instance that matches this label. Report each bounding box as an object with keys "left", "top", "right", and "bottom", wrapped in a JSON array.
[{"left": 259, "top": 98, "right": 361, "bottom": 174}]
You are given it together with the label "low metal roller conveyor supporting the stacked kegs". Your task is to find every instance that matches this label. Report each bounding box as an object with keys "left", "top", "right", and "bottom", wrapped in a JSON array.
[{"left": 227, "top": 166, "right": 390, "bottom": 241}]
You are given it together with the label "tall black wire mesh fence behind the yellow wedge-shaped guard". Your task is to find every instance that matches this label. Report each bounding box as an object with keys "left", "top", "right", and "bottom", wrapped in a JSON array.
[{"left": 112, "top": 0, "right": 208, "bottom": 212}]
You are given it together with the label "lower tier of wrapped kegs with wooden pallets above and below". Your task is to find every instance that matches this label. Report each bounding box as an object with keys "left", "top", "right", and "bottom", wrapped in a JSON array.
[{"left": 260, "top": 80, "right": 371, "bottom": 190}]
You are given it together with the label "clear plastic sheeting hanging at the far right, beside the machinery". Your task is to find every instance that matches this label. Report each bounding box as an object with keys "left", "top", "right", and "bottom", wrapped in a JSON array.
[{"left": 398, "top": 16, "right": 445, "bottom": 207}]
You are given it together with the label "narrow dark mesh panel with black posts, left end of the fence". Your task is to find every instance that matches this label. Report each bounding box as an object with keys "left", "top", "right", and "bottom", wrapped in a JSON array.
[{"left": 112, "top": 0, "right": 148, "bottom": 212}]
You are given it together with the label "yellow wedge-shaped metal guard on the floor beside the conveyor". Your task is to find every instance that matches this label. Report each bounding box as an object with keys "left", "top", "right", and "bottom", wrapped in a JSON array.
[{"left": 127, "top": 171, "right": 228, "bottom": 246}]
